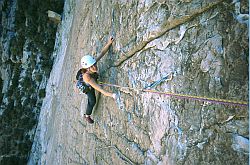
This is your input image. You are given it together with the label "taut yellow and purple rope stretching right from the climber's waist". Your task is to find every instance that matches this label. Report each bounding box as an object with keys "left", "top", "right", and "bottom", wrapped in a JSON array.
[{"left": 99, "top": 82, "right": 248, "bottom": 107}]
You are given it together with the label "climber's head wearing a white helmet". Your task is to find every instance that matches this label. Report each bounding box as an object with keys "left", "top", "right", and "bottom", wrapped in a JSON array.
[{"left": 81, "top": 55, "right": 97, "bottom": 72}]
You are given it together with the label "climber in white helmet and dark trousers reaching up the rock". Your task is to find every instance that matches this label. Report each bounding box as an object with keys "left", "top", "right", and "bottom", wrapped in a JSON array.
[{"left": 77, "top": 37, "right": 116, "bottom": 124}]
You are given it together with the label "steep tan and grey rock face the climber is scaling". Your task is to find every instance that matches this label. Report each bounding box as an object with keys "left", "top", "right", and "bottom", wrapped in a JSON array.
[{"left": 29, "top": 0, "right": 249, "bottom": 164}]
